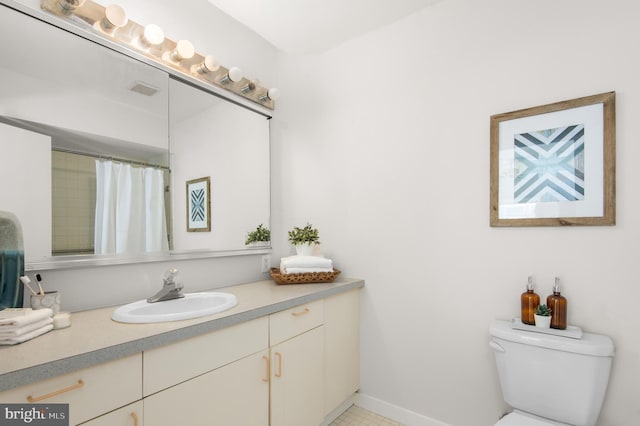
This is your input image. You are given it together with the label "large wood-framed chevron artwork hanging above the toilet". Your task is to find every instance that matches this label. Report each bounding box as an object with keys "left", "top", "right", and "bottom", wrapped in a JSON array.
[{"left": 489, "top": 92, "right": 616, "bottom": 226}]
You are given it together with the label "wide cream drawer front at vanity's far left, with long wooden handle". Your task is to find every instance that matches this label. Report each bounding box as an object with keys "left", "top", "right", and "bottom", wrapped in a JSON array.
[{"left": 0, "top": 354, "right": 142, "bottom": 425}]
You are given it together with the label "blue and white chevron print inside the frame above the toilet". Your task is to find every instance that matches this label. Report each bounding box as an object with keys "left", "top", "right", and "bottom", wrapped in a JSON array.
[{"left": 513, "top": 124, "right": 584, "bottom": 203}]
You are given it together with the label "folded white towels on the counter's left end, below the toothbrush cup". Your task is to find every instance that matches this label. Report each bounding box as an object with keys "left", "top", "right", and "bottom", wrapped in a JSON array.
[{"left": 0, "top": 308, "right": 53, "bottom": 345}]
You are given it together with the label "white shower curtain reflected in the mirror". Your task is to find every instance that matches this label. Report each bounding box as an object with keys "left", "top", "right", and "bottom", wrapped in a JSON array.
[{"left": 94, "top": 160, "right": 169, "bottom": 254}]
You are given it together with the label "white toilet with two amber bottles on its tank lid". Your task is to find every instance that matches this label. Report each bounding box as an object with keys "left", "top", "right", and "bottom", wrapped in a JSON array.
[{"left": 489, "top": 320, "right": 613, "bottom": 426}]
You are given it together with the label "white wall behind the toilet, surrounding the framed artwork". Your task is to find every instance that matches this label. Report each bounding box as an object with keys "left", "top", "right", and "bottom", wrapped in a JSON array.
[{"left": 272, "top": 0, "right": 640, "bottom": 426}]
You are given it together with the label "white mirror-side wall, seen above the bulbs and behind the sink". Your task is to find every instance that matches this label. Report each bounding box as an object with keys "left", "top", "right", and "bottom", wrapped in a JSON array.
[{"left": 0, "top": 0, "right": 277, "bottom": 311}]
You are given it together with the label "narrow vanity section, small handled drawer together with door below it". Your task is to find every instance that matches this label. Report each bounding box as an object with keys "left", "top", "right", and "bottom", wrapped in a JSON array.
[{"left": 269, "top": 300, "right": 324, "bottom": 426}]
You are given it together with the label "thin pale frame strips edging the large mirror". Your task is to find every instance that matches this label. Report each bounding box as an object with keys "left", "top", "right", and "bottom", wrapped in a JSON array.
[{"left": 0, "top": 0, "right": 273, "bottom": 272}]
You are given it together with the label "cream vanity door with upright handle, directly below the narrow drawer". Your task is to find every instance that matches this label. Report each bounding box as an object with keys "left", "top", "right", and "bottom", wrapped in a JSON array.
[{"left": 270, "top": 326, "right": 324, "bottom": 426}]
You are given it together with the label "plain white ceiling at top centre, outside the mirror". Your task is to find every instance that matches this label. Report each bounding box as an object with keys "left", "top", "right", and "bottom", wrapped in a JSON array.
[{"left": 209, "top": 0, "right": 441, "bottom": 54}]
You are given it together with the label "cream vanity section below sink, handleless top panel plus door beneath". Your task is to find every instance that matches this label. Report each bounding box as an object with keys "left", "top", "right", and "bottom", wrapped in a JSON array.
[{"left": 143, "top": 317, "right": 269, "bottom": 426}]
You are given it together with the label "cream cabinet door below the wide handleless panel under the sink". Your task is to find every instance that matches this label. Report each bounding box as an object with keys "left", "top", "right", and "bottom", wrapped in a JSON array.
[{"left": 144, "top": 350, "right": 268, "bottom": 426}]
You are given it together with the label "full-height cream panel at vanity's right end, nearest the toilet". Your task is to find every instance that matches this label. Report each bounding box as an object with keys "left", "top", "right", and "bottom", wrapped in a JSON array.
[{"left": 324, "top": 290, "right": 360, "bottom": 414}]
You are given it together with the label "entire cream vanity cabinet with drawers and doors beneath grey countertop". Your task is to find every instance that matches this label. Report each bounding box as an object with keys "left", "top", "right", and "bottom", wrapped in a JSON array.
[{"left": 0, "top": 284, "right": 360, "bottom": 426}]
